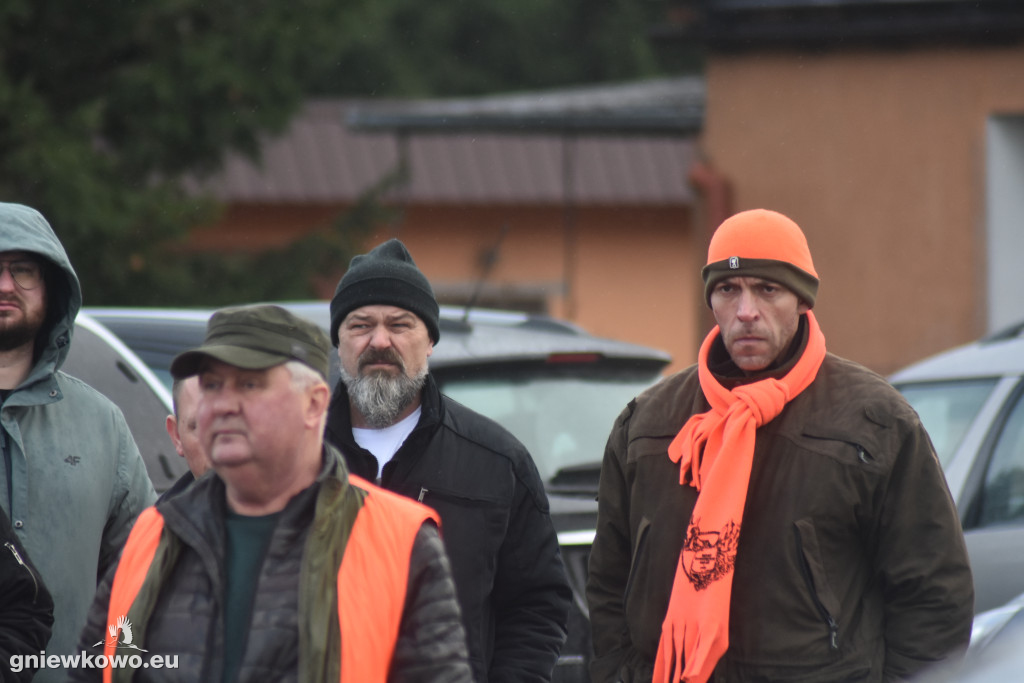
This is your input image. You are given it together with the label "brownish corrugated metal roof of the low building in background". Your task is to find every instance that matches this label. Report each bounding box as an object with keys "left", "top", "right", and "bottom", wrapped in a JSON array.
[{"left": 193, "top": 80, "right": 695, "bottom": 204}]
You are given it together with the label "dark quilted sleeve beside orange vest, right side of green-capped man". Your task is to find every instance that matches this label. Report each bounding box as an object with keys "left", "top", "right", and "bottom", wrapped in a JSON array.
[{"left": 388, "top": 523, "right": 473, "bottom": 683}]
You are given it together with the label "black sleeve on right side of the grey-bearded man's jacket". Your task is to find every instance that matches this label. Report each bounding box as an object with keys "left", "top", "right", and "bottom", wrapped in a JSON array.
[{"left": 487, "top": 452, "right": 572, "bottom": 683}]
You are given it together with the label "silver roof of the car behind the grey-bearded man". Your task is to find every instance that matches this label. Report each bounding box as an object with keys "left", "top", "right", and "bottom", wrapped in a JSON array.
[{"left": 84, "top": 301, "right": 671, "bottom": 371}]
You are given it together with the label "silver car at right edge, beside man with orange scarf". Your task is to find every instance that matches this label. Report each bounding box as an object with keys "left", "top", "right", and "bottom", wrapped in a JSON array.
[{"left": 890, "top": 324, "right": 1024, "bottom": 612}]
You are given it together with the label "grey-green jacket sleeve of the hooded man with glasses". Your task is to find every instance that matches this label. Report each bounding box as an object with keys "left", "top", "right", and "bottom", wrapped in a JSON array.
[{"left": 96, "top": 411, "right": 157, "bottom": 581}]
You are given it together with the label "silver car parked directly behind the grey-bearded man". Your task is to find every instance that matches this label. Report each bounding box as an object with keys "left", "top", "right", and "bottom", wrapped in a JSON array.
[{"left": 81, "top": 301, "right": 670, "bottom": 683}]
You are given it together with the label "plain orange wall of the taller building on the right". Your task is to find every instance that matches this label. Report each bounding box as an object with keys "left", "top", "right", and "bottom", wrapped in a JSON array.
[{"left": 697, "top": 47, "right": 1024, "bottom": 373}]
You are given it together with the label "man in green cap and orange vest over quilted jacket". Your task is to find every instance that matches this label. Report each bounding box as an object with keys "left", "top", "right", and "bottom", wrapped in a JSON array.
[{"left": 73, "top": 305, "right": 471, "bottom": 683}]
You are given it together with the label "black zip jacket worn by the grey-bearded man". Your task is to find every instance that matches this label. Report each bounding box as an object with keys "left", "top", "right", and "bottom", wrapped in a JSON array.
[{"left": 326, "top": 376, "right": 571, "bottom": 683}]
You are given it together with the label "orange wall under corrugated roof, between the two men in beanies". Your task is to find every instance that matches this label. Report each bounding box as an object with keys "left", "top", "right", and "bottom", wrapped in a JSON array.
[{"left": 368, "top": 206, "right": 700, "bottom": 370}]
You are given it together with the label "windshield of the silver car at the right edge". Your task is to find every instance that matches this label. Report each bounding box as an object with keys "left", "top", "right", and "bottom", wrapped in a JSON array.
[{"left": 896, "top": 379, "right": 996, "bottom": 467}]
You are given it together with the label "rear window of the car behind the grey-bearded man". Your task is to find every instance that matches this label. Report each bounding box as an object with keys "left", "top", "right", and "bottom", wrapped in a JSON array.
[{"left": 440, "top": 374, "right": 657, "bottom": 490}]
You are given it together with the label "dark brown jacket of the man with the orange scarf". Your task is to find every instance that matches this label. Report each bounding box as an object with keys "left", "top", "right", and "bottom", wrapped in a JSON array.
[{"left": 587, "top": 354, "right": 974, "bottom": 683}]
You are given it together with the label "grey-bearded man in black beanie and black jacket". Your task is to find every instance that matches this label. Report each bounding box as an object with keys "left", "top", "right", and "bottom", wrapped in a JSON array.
[{"left": 326, "top": 240, "right": 571, "bottom": 683}]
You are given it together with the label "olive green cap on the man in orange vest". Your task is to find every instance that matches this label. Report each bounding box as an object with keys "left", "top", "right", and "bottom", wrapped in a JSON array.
[{"left": 171, "top": 304, "right": 331, "bottom": 379}]
